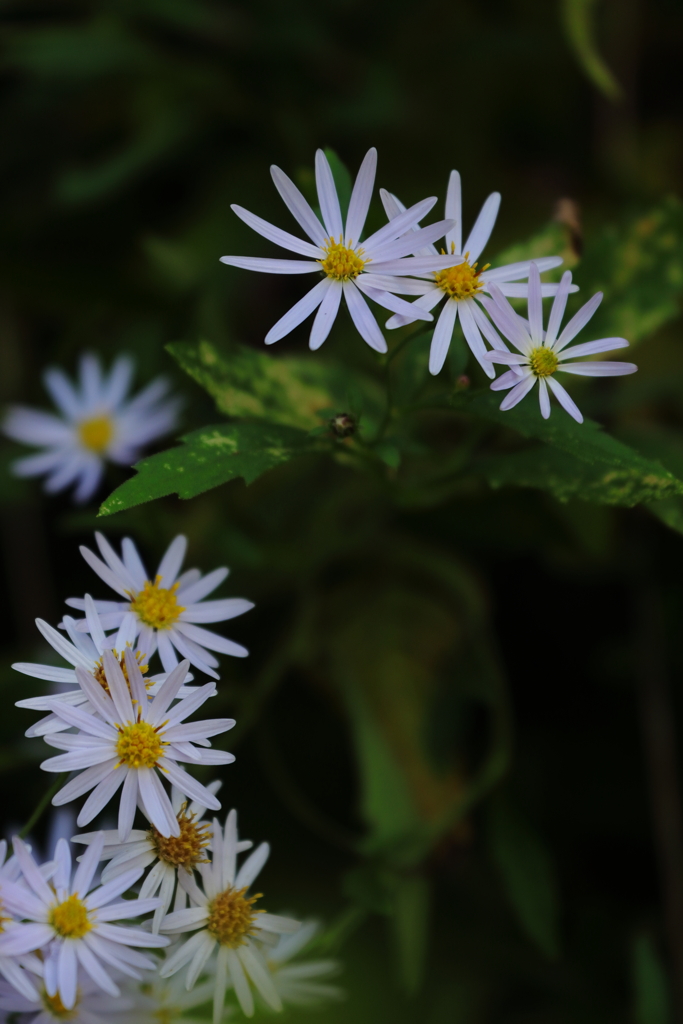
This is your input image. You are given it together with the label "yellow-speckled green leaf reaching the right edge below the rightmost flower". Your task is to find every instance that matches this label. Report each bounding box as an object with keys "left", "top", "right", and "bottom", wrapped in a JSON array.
[{"left": 451, "top": 391, "right": 683, "bottom": 506}]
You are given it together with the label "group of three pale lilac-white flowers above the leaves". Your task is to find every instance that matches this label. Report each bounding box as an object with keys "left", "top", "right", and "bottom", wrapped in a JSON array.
[{"left": 222, "top": 150, "right": 637, "bottom": 422}]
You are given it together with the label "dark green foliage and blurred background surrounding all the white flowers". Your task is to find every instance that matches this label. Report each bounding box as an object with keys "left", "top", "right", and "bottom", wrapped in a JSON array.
[{"left": 0, "top": 0, "right": 683, "bottom": 1024}]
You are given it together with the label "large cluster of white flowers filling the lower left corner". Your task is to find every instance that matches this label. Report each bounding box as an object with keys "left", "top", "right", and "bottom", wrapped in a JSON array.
[{"left": 0, "top": 535, "right": 339, "bottom": 1024}]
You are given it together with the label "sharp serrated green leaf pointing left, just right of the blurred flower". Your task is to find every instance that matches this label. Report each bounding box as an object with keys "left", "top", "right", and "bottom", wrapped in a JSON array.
[{"left": 99, "top": 423, "right": 314, "bottom": 515}]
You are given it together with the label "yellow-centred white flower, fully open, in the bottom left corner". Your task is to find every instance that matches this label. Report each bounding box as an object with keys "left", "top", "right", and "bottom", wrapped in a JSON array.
[{"left": 0, "top": 835, "right": 168, "bottom": 1010}]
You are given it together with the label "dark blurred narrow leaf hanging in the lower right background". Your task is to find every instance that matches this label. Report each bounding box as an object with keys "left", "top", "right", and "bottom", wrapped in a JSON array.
[{"left": 487, "top": 800, "right": 559, "bottom": 958}]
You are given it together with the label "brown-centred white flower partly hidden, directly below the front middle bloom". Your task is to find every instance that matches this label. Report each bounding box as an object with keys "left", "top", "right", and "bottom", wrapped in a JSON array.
[{"left": 72, "top": 781, "right": 252, "bottom": 932}]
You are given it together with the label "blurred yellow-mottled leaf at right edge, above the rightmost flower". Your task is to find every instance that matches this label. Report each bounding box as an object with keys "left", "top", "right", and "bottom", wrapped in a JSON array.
[{"left": 575, "top": 198, "right": 683, "bottom": 344}]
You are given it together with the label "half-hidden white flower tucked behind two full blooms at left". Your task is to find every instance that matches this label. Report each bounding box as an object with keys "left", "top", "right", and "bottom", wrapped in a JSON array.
[{"left": 12, "top": 594, "right": 195, "bottom": 737}]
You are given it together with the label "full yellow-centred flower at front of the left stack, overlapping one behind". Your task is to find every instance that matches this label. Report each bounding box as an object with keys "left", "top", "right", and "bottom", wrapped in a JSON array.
[{"left": 41, "top": 648, "right": 234, "bottom": 842}]
